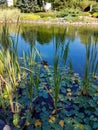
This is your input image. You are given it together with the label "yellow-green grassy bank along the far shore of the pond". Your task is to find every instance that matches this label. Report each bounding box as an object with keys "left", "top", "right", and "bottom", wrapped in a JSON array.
[{"left": 0, "top": 9, "right": 98, "bottom": 23}]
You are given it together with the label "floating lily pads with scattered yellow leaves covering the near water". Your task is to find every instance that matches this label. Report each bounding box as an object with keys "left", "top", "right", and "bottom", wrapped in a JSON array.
[{"left": 1, "top": 60, "right": 98, "bottom": 130}]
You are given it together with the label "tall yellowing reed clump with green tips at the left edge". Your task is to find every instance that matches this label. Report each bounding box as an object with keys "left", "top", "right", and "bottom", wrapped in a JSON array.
[{"left": 0, "top": 21, "right": 21, "bottom": 113}]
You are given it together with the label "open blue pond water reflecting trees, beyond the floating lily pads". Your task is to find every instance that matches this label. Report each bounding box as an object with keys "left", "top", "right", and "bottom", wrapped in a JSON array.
[{"left": 2, "top": 25, "right": 98, "bottom": 76}]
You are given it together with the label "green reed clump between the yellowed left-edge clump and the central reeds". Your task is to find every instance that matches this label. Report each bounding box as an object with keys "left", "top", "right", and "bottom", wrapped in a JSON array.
[{"left": 21, "top": 46, "right": 41, "bottom": 112}]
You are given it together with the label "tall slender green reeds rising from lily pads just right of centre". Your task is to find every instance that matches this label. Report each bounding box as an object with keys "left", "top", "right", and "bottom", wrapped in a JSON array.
[{"left": 53, "top": 29, "right": 72, "bottom": 109}]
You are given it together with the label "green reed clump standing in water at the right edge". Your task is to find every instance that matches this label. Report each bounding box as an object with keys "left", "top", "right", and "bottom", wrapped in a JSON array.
[{"left": 82, "top": 43, "right": 98, "bottom": 95}]
